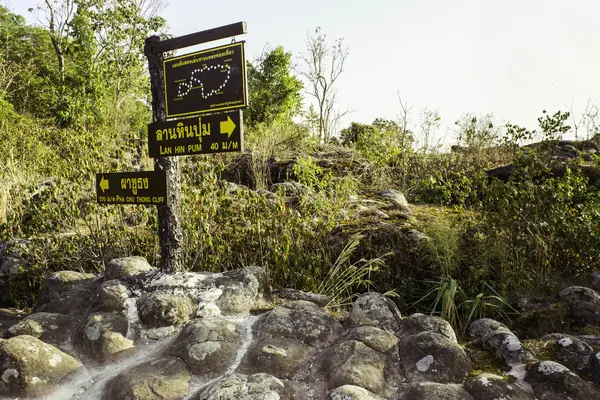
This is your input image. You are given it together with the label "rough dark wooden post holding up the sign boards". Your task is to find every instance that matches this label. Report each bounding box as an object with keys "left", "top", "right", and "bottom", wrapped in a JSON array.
[{"left": 144, "top": 36, "right": 183, "bottom": 273}]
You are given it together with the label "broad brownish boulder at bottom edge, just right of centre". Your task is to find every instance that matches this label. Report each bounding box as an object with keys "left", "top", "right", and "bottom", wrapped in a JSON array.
[{"left": 311, "top": 340, "right": 402, "bottom": 397}]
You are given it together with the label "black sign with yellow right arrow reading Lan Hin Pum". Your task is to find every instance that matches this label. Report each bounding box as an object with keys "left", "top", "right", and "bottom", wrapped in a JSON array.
[{"left": 148, "top": 110, "right": 244, "bottom": 158}]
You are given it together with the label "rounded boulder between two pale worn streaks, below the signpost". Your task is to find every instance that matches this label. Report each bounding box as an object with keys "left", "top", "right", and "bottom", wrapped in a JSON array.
[{"left": 171, "top": 318, "right": 245, "bottom": 375}]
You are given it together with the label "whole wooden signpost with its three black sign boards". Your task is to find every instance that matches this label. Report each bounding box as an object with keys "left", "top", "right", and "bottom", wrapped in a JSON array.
[{"left": 96, "top": 22, "right": 248, "bottom": 273}]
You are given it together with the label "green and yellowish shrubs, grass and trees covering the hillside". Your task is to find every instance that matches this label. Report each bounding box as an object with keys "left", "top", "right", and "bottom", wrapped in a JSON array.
[{"left": 0, "top": 0, "right": 600, "bottom": 338}]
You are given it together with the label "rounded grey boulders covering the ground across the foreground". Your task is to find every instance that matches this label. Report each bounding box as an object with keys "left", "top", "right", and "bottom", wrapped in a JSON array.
[{"left": 0, "top": 257, "right": 600, "bottom": 400}]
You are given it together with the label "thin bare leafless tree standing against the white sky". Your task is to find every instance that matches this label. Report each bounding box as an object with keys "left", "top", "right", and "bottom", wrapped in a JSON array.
[{"left": 301, "top": 27, "right": 348, "bottom": 141}]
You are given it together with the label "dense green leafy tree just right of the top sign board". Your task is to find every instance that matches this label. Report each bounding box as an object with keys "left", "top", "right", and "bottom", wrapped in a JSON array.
[{"left": 244, "top": 46, "right": 304, "bottom": 126}]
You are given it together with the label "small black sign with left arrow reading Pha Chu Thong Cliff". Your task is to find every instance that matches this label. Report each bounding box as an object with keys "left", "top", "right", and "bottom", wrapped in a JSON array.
[{"left": 96, "top": 171, "right": 167, "bottom": 205}]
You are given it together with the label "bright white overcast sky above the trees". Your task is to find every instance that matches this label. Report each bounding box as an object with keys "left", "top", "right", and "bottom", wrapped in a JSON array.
[{"left": 5, "top": 0, "right": 600, "bottom": 146}]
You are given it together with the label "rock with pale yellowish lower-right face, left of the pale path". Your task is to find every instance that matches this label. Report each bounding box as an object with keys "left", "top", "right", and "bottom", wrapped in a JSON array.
[{"left": 74, "top": 312, "right": 133, "bottom": 363}]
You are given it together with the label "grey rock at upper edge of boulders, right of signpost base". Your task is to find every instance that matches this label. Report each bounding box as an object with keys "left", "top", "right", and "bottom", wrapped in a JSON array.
[{"left": 214, "top": 267, "right": 267, "bottom": 314}]
